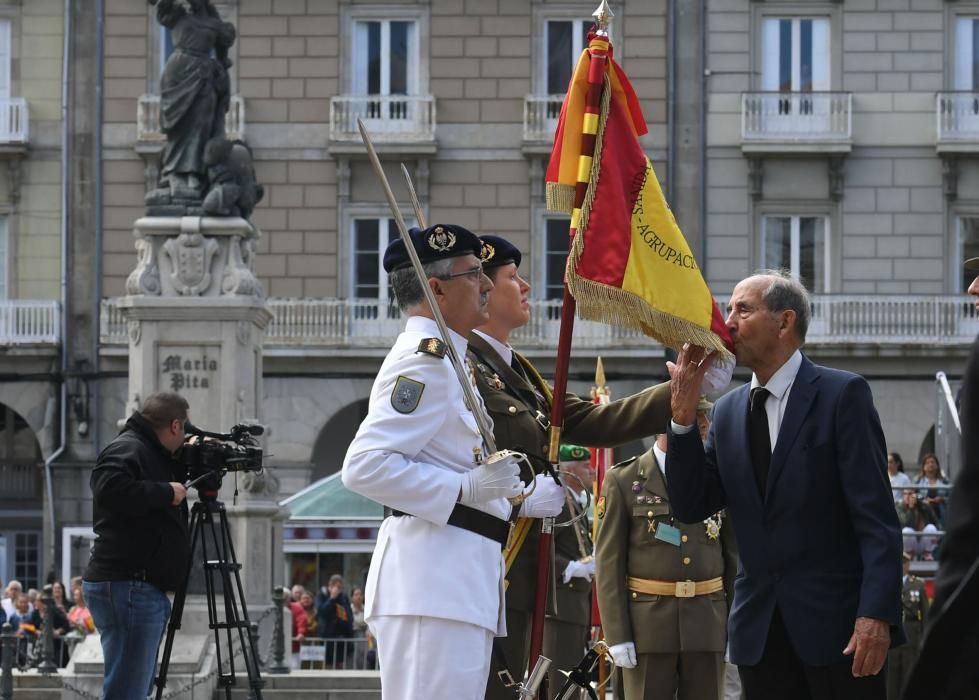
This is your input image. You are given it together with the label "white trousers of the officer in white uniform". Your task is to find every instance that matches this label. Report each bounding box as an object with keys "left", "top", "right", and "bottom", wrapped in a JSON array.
[{"left": 370, "top": 615, "right": 495, "bottom": 700}]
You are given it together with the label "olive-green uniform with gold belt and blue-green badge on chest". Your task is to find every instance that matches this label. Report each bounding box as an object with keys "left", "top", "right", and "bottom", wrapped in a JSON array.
[{"left": 595, "top": 450, "right": 737, "bottom": 700}]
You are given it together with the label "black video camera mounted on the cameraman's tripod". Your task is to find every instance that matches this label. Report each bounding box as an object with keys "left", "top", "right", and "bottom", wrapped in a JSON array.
[{"left": 180, "top": 421, "right": 265, "bottom": 488}]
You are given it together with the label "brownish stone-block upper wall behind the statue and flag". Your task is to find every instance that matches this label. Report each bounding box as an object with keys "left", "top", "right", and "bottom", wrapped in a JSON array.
[{"left": 104, "top": 0, "right": 666, "bottom": 297}]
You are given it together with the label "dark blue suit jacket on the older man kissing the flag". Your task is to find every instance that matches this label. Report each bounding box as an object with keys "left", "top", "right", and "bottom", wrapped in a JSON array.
[{"left": 666, "top": 357, "right": 904, "bottom": 666}]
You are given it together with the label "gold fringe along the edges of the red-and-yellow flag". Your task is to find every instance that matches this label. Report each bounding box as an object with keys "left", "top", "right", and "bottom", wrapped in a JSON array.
[{"left": 564, "top": 76, "right": 731, "bottom": 358}]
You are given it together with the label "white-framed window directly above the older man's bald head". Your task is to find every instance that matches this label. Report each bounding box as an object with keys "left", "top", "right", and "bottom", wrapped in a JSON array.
[{"left": 761, "top": 216, "right": 830, "bottom": 294}]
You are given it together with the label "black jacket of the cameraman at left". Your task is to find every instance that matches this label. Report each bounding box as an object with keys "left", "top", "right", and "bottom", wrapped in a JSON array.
[{"left": 85, "top": 413, "right": 190, "bottom": 591}]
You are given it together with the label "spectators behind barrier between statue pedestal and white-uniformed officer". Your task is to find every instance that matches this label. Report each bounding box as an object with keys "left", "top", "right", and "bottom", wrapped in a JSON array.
[{"left": 285, "top": 574, "right": 377, "bottom": 669}]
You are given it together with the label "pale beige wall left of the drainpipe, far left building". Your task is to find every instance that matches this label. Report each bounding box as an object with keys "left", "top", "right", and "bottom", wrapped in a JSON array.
[{"left": 13, "top": 0, "right": 64, "bottom": 299}]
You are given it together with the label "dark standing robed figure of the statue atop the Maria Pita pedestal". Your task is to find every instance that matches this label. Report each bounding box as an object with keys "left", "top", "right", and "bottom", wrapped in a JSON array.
[{"left": 146, "top": 0, "right": 243, "bottom": 216}]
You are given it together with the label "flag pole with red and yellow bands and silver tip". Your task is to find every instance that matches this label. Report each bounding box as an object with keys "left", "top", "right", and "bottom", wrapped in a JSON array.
[{"left": 527, "top": 0, "right": 612, "bottom": 700}]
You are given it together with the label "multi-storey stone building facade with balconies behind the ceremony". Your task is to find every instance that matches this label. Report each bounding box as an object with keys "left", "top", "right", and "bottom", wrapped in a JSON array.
[{"left": 0, "top": 0, "right": 979, "bottom": 578}]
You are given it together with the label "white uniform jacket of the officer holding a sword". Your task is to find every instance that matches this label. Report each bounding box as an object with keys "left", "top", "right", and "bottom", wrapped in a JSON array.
[{"left": 342, "top": 316, "right": 510, "bottom": 635}]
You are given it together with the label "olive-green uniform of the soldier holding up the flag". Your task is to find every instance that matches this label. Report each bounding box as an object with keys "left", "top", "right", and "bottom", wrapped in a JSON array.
[{"left": 469, "top": 333, "right": 671, "bottom": 700}]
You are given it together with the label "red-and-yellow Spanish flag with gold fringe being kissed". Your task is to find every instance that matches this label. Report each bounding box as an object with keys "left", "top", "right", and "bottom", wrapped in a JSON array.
[{"left": 546, "top": 35, "right": 731, "bottom": 357}]
